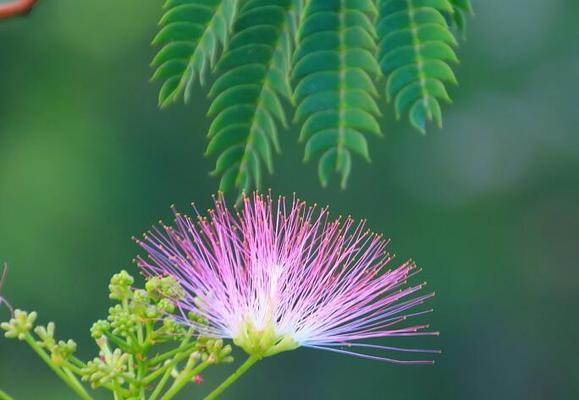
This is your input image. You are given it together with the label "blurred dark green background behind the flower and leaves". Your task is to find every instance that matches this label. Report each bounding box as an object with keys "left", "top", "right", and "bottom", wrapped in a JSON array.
[{"left": 0, "top": 0, "right": 579, "bottom": 400}]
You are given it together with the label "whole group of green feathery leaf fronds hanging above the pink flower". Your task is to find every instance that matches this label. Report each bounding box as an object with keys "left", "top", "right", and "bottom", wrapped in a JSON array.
[{"left": 153, "top": 0, "right": 472, "bottom": 193}]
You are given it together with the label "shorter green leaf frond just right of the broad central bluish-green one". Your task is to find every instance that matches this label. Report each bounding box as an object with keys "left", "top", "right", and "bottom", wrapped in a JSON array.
[{"left": 377, "top": 0, "right": 458, "bottom": 132}]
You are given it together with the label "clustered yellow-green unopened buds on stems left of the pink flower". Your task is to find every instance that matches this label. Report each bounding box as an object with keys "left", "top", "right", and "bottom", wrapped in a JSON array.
[{"left": 0, "top": 271, "right": 233, "bottom": 399}]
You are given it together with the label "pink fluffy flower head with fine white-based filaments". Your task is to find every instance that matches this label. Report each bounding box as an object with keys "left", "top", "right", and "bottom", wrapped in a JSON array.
[{"left": 136, "top": 194, "right": 437, "bottom": 363}]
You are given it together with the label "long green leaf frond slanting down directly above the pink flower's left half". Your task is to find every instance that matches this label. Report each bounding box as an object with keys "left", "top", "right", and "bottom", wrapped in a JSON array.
[{"left": 206, "top": 0, "right": 299, "bottom": 191}]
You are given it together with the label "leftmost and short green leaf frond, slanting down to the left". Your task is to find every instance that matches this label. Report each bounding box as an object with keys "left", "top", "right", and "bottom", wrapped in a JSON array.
[{"left": 152, "top": 0, "right": 237, "bottom": 107}]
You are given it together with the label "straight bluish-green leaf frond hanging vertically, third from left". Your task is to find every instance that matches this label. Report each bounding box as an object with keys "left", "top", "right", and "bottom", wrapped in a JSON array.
[{"left": 293, "top": 0, "right": 381, "bottom": 187}]
